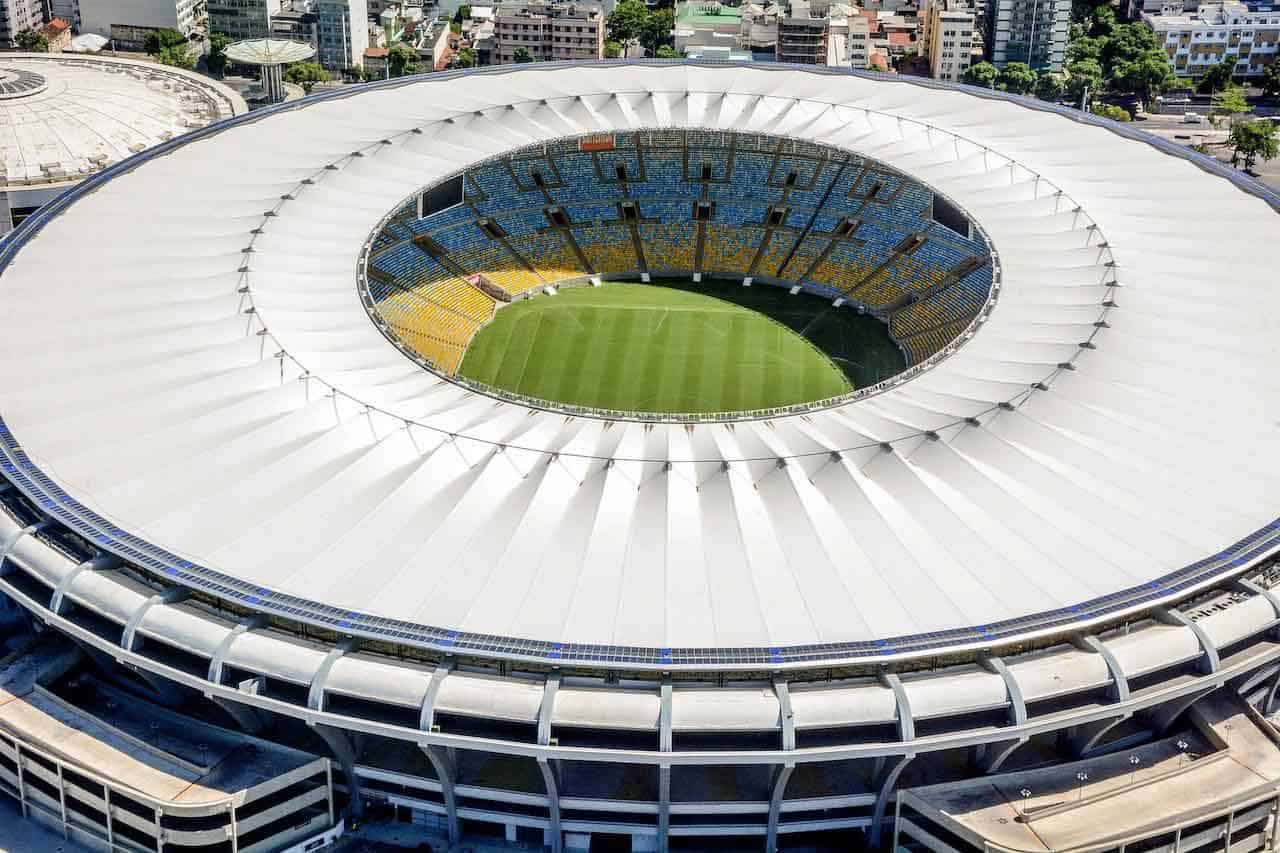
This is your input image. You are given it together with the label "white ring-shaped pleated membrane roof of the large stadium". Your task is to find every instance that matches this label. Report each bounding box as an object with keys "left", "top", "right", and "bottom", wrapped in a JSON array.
[{"left": 0, "top": 63, "right": 1280, "bottom": 666}]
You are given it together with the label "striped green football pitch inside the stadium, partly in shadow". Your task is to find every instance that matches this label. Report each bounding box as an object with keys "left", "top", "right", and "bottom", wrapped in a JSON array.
[{"left": 458, "top": 282, "right": 904, "bottom": 412}]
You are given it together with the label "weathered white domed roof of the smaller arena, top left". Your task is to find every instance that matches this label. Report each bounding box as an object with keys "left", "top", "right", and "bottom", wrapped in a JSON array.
[{"left": 0, "top": 54, "right": 248, "bottom": 188}]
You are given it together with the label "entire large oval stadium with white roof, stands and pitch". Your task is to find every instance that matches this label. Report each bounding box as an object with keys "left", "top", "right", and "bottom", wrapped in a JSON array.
[{"left": 0, "top": 61, "right": 1280, "bottom": 853}]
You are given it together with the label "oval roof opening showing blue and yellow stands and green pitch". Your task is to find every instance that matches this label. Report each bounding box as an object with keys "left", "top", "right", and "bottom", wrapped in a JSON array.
[{"left": 361, "top": 129, "right": 996, "bottom": 420}]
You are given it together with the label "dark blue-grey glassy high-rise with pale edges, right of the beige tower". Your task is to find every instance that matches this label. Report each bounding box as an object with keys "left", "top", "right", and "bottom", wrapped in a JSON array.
[{"left": 986, "top": 0, "right": 1071, "bottom": 72}]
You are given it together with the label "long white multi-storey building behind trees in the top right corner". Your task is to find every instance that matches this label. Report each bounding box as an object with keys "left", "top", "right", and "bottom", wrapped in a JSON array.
[{"left": 1143, "top": 1, "right": 1280, "bottom": 77}]
